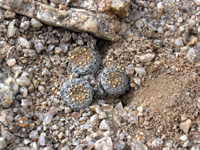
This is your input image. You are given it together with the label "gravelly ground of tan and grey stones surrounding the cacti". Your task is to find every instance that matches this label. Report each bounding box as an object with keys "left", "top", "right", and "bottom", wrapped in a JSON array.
[{"left": 0, "top": 0, "right": 200, "bottom": 150}]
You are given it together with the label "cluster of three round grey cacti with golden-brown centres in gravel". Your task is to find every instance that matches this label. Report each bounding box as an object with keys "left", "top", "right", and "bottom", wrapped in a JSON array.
[{"left": 60, "top": 46, "right": 129, "bottom": 111}]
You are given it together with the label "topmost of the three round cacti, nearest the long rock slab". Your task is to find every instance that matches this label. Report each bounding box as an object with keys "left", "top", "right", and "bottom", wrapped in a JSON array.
[{"left": 69, "top": 46, "right": 101, "bottom": 75}]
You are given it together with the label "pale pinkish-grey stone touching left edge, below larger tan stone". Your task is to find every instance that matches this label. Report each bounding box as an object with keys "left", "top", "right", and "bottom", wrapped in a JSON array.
[{"left": 0, "top": 109, "right": 13, "bottom": 126}]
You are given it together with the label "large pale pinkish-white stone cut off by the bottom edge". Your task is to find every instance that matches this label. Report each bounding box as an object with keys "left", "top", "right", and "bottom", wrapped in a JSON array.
[{"left": 94, "top": 137, "right": 113, "bottom": 150}]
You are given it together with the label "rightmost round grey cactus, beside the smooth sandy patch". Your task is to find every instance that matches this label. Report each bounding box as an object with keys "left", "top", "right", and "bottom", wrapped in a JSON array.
[{"left": 101, "top": 68, "right": 129, "bottom": 96}]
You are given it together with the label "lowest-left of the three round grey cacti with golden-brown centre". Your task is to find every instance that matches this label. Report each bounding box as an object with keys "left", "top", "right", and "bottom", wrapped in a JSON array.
[{"left": 60, "top": 78, "right": 93, "bottom": 111}]
